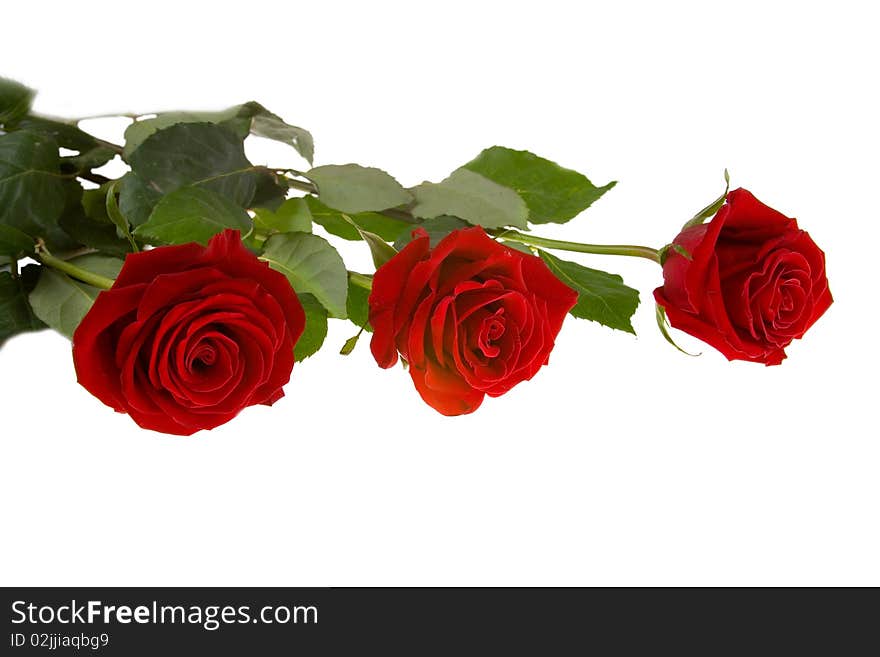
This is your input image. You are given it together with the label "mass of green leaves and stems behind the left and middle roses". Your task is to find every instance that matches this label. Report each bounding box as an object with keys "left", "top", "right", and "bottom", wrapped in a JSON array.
[{"left": 0, "top": 79, "right": 638, "bottom": 360}]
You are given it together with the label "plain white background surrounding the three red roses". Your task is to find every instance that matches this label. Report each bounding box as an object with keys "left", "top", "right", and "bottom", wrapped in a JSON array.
[{"left": 0, "top": 0, "right": 880, "bottom": 585}]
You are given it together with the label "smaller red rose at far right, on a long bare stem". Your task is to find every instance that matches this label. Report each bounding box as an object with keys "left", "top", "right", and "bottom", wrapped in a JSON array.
[{"left": 654, "top": 189, "right": 832, "bottom": 365}]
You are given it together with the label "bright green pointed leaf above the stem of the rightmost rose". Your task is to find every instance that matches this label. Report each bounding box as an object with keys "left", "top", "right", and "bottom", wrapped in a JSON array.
[{"left": 464, "top": 146, "right": 617, "bottom": 224}]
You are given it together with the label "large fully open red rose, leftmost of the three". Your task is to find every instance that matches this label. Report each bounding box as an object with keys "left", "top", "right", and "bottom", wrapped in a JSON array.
[{"left": 73, "top": 230, "right": 305, "bottom": 435}]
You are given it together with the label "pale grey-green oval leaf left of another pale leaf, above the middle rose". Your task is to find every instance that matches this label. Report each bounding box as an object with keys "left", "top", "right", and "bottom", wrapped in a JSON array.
[{"left": 306, "top": 164, "right": 412, "bottom": 214}]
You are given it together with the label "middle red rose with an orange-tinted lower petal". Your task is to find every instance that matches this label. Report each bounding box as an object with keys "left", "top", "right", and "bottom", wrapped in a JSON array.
[{"left": 370, "top": 228, "right": 577, "bottom": 415}]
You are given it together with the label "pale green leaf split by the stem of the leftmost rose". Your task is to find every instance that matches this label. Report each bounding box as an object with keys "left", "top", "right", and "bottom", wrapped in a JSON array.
[{"left": 30, "top": 255, "right": 122, "bottom": 338}]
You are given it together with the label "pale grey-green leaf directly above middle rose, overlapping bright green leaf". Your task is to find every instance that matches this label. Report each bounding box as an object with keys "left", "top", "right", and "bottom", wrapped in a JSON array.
[{"left": 410, "top": 169, "right": 529, "bottom": 228}]
